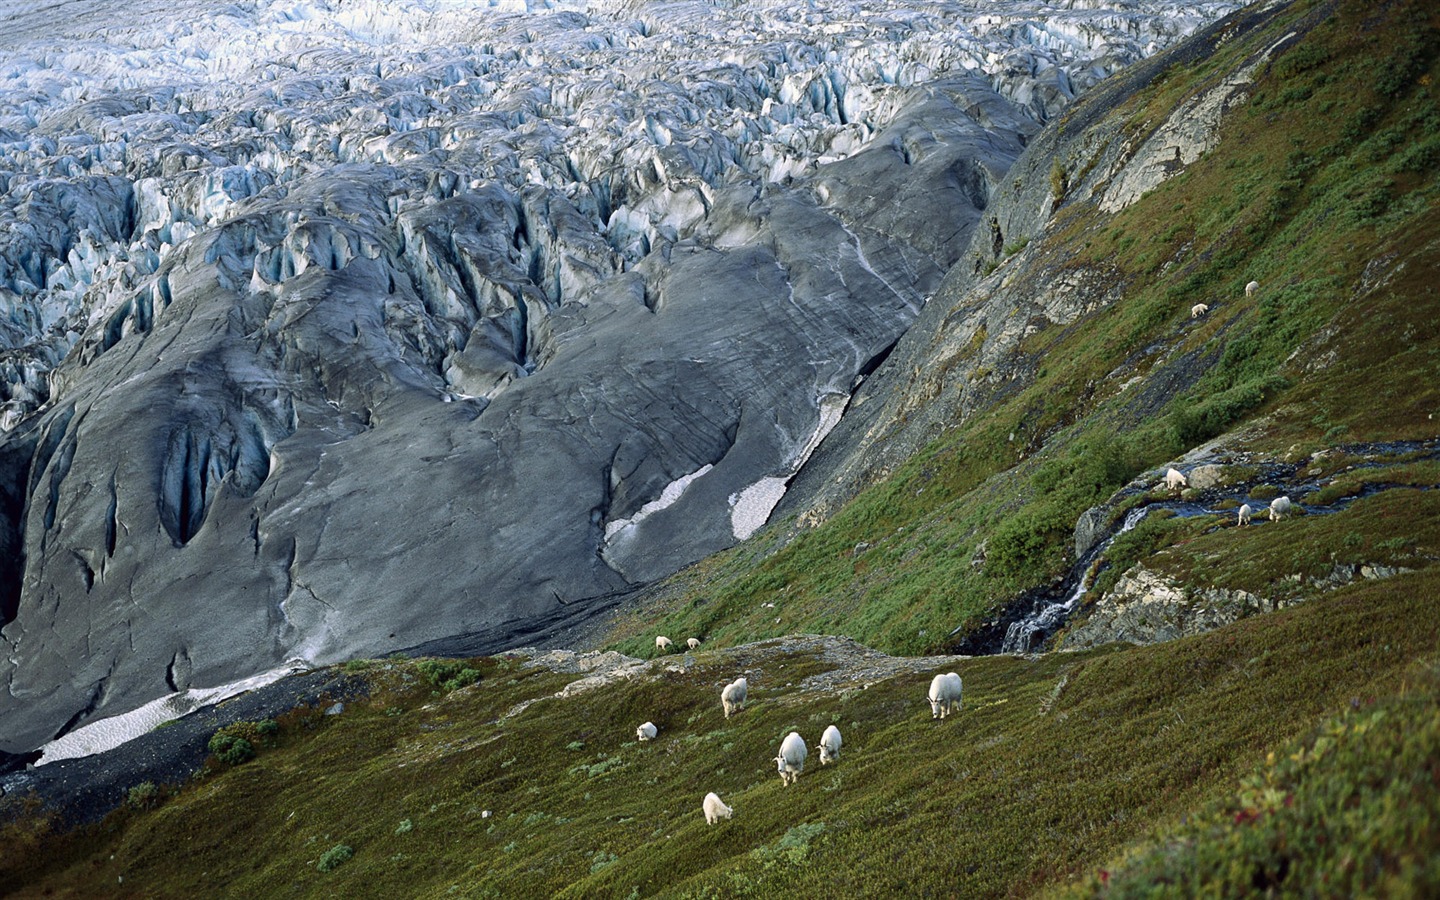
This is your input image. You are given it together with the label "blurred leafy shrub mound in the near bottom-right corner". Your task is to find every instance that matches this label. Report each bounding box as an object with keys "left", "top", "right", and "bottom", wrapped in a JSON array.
[{"left": 1067, "top": 662, "right": 1440, "bottom": 897}]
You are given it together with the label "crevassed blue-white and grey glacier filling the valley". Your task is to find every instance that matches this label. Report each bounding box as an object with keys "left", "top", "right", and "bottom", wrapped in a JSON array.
[{"left": 0, "top": 0, "right": 1234, "bottom": 752}]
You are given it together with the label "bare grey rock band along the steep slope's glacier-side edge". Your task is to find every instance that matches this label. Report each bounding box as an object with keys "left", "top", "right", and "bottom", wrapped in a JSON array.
[{"left": 782, "top": 3, "right": 1323, "bottom": 524}]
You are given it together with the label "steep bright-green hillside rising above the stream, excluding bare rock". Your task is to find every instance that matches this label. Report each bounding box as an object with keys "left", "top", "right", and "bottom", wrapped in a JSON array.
[{"left": 593, "top": 0, "right": 1440, "bottom": 652}]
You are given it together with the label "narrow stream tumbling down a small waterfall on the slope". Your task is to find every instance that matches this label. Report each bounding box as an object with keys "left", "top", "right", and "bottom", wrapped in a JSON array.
[{"left": 952, "top": 441, "right": 1440, "bottom": 655}]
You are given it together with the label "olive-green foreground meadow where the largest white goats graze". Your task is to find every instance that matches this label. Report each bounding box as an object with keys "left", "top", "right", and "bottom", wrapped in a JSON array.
[{"left": 0, "top": 570, "right": 1440, "bottom": 897}]
